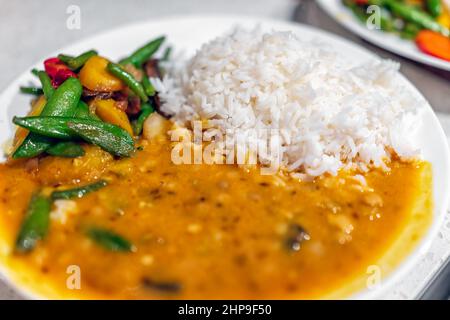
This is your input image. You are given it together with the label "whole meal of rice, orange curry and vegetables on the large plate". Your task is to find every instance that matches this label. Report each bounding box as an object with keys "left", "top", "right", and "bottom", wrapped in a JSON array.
[{"left": 0, "top": 28, "right": 433, "bottom": 299}]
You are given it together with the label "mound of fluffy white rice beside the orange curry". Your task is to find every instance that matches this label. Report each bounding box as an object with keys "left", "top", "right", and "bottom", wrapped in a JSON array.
[{"left": 152, "top": 29, "right": 425, "bottom": 176}]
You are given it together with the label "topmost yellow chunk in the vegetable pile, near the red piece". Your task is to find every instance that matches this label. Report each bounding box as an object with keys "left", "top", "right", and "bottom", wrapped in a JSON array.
[{"left": 79, "top": 56, "right": 125, "bottom": 92}]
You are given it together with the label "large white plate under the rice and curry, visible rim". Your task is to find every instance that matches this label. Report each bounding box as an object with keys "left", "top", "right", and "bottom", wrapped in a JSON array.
[{"left": 0, "top": 16, "right": 450, "bottom": 298}]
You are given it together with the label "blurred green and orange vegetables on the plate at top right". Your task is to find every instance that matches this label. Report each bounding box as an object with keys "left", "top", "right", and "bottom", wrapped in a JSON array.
[{"left": 343, "top": 0, "right": 450, "bottom": 61}]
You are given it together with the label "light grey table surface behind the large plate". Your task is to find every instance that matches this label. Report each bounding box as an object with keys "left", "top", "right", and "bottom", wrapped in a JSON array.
[{"left": 0, "top": 0, "right": 450, "bottom": 299}]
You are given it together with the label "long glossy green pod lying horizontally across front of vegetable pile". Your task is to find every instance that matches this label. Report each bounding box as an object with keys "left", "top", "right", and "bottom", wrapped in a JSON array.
[{"left": 13, "top": 116, "right": 134, "bottom": 157}]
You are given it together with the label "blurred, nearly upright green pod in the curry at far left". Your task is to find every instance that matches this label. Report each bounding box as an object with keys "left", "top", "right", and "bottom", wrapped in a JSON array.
[{"left": 16, "top": 194, "right": 51, "bottom": 253}]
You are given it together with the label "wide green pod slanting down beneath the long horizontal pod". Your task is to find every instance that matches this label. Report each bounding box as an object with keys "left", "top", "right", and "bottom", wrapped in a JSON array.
[{"left": 12, "top": 78, "right": 83, "bottom": 159}]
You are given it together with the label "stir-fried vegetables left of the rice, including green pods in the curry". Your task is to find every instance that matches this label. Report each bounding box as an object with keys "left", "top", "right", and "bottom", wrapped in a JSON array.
[{"left": 11, "top": 37, "right": 170, "bottom": 252}]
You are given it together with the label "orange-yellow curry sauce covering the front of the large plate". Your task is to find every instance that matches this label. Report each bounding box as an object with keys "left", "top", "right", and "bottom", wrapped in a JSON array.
[{"left": 0, "top": 134, "right": 432, "bottom": 299}]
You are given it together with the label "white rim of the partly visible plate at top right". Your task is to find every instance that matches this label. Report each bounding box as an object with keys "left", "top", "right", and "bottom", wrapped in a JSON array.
[{"left": 317, "top": 0, "right": 450, "bottom": 71}]
